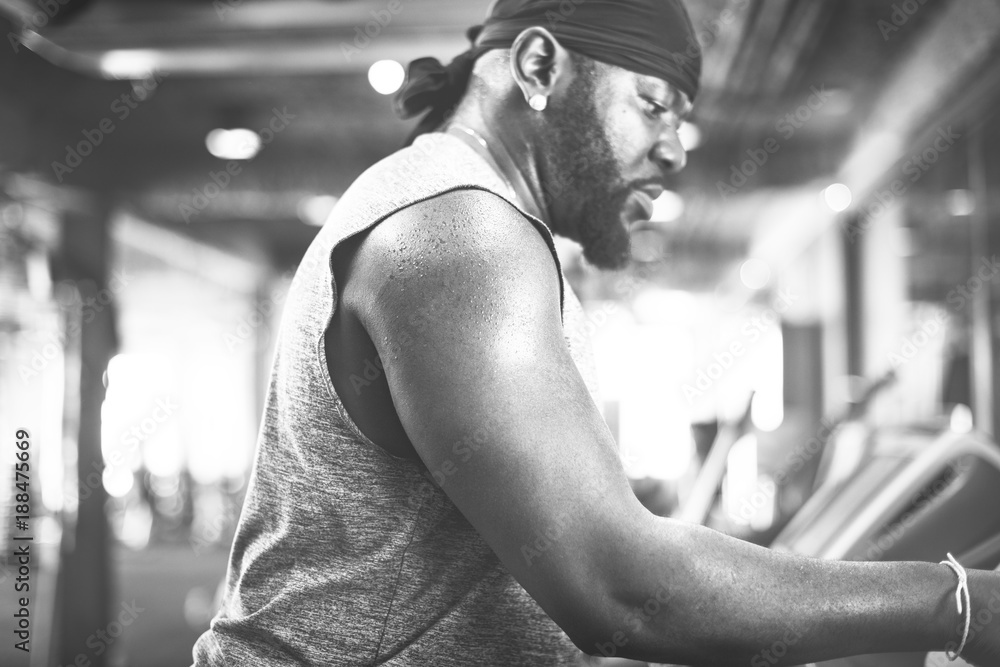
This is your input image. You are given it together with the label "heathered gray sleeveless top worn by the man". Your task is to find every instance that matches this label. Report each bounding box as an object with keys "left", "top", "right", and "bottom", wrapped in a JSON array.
[{"left": 194, "top": 133, "right": 599, "bottom": 667}]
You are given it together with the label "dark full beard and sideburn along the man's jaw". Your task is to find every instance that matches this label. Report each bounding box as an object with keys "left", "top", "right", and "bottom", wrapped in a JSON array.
[{"left": 542, "top": 58, "right": 632, "bottom": 269}]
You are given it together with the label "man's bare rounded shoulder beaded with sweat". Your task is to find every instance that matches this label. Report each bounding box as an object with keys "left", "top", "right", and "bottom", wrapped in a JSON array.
[{"left": 343, "top": 189, "right": 562, "bottom": 338}]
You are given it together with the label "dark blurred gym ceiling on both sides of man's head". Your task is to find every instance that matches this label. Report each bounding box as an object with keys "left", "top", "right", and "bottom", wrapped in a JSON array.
[{"left": 0, "top": 0, "right": 1000, "bottom": 289}]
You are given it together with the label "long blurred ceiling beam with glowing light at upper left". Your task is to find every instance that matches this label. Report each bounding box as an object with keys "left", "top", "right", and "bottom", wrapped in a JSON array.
[{"left": 7, "top": 0, "right": 486, "bottom": 79}]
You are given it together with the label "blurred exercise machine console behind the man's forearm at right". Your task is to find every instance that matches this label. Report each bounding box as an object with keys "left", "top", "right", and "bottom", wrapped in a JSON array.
[{"left": 772, "top": 427, "right": 1000, "bottom": 667}]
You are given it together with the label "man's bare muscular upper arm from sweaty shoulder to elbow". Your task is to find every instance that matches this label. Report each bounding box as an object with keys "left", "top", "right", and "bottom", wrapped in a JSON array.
[{"left": 351, "top": 191, "right": 646, "bottom": 644}]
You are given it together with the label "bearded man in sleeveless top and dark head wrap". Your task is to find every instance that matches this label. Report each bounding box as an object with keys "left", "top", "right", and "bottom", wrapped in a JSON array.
[{"left": 195, "top": 0, "right": 1000, "bottom": 667}]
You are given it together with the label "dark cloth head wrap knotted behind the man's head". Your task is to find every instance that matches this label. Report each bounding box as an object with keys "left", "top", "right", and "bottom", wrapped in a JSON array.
[{"left": 395, "top": 0, "right": 701, "bottom": 140}]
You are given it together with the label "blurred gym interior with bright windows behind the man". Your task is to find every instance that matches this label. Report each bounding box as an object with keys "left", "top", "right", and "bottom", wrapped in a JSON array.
[{"left": 0, "top": 0, "right": 1000, "bottom": 667}]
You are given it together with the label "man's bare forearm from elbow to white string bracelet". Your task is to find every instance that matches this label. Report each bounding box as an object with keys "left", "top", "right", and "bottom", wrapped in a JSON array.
[{"left": 588, "top": 519, "right": 980, "bottom": 667}]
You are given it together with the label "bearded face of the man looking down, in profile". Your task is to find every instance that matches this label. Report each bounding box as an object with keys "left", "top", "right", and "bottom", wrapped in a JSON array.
[{"left": 540, "top": 57, "right": 690, "bottom": 269}]
